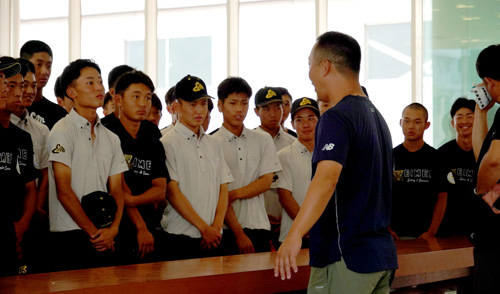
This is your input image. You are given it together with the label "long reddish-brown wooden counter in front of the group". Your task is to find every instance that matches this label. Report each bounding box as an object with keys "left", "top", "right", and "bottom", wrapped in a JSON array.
[{"left": 0, "top": 238, "right": 473, "bottom": 294}]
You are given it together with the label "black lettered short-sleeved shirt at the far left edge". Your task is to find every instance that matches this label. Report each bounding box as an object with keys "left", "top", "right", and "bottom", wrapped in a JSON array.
[{"left": 0, "top": 124, "right": 39, "bottom": 222}]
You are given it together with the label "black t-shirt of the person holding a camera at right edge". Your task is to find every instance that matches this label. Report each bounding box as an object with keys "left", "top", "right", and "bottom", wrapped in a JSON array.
[{"left": 472, "top": 109, "right": 500, "bottom": 248}]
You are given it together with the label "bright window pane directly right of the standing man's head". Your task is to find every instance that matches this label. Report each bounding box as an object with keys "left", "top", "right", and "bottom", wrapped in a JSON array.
[{"left": 328, "top": 0, "right": 410, "bottom": 145}]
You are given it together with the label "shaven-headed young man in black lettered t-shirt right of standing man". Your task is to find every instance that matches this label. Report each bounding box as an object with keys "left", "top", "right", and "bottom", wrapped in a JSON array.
[{"left": 391, "top": 103, "right": 446, "bottom": 240}]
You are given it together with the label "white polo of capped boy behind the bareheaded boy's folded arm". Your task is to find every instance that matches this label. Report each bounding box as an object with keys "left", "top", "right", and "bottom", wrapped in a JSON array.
[{"left": 256, "top": 126, "right": 296, "bottom": 217}]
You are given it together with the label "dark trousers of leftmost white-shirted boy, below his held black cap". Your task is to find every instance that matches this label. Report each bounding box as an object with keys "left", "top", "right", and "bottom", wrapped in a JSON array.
[{"left": 51, "top": 230, "right": 117, "bottom": 271}]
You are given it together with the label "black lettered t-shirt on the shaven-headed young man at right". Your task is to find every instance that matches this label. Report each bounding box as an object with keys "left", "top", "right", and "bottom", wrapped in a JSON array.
[{"left": 391, "top": 143, "right": 442, "bottom": 238}]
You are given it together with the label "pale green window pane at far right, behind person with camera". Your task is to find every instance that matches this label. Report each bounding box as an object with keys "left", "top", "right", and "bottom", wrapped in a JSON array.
[{"left": 424, "top": 0, "right": 500, "bottom": 147}]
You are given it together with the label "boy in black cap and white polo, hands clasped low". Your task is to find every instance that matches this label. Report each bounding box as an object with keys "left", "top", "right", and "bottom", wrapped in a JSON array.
[{"left": 160, "top": 75, "right": 233, "bottom": 260}]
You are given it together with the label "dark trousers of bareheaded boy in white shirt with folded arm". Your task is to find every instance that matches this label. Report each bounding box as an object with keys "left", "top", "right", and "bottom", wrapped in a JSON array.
[{"left": 222, "top": 228, "right": 271, "bottom": 255}]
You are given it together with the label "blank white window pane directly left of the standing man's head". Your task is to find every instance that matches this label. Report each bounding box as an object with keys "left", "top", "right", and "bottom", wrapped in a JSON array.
[{"left": 239, "top": 0, "right": 316, "bottom": 129}]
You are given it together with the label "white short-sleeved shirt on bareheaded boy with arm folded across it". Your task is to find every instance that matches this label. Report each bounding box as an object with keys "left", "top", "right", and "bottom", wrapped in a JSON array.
[{"left": 213, "top": 126, "right": 281, "bottom": 230}]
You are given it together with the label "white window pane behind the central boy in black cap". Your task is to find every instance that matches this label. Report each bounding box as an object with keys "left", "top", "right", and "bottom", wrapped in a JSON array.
[{"left": 156, "top": 1, "right": 227, "bottom": 131}]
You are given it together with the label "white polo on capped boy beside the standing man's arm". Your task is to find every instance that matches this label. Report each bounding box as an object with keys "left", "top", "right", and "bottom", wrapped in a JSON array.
[{"left": 276, "top": 139, "right": 312, "bottom": 242}]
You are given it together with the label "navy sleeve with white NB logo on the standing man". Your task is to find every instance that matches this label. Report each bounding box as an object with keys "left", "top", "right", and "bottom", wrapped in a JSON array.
[{"left": 312, "top": 109, "right": 351, "bottom": 166}]
